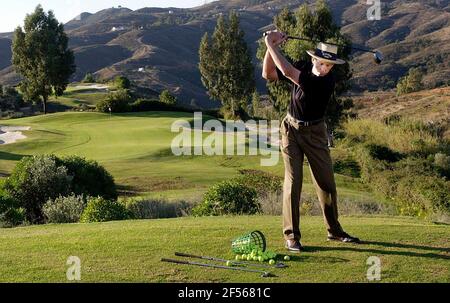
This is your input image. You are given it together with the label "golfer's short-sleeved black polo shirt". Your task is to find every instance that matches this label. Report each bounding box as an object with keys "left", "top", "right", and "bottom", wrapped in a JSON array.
[{"left": 277, "top": 61, "right": 336, "bottom": 121}]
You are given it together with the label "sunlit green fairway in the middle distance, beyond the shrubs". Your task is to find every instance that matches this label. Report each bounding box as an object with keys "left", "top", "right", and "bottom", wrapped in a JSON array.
[{"left": 0, "top": 112, "right": 371, "bottom": 200}]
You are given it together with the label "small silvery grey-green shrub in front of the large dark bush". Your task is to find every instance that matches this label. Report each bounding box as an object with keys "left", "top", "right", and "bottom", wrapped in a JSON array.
[{"left": 42, "top": 194, "right": 86, "bottom": 223}]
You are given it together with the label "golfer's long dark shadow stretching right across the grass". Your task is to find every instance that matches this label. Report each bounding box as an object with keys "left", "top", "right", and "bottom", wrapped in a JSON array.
[{"left": 305, "top": 241, "right": 450, "bottom": 260}]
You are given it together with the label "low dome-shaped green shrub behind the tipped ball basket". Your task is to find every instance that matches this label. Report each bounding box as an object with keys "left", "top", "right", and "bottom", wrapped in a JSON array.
[{"left": 192, "top": 180, "right": 261, "bottom": 216}]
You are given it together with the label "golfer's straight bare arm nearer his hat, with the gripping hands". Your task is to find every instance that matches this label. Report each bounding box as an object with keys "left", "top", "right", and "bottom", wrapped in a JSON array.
[{"left": 266, "top": 32, "right": 300, "bottom": 85}]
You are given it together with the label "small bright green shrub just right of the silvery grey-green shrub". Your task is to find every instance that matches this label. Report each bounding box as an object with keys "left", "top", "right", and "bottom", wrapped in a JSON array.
[{"left": 80, "top": 197, "right": 131, "bottom": 223}]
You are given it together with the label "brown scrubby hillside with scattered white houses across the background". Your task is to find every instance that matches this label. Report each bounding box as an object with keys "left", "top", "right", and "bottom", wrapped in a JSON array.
[{"left": 0, "top": 0, "right": 450, "bottom": 107}]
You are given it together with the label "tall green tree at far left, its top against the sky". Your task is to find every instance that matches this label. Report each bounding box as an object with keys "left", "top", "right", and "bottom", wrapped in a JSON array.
[{"left": 12, "top": 5, "right": 76, "bottom": 113}]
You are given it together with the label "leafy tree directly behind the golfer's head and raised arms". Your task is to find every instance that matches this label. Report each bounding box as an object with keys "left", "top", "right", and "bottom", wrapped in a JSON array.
[{"left": 257, "top": 0, "right": 352, "bottom": 130}]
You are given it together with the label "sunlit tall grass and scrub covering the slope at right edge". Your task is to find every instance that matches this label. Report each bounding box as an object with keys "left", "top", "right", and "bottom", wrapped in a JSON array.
[{"left": 338, "top": 119, "right": 450, "bottom": 218}]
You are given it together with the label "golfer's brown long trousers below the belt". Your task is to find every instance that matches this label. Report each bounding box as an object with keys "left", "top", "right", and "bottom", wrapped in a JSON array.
[{"left": 280, "top": 117, "right": 343, "bottom": 240}]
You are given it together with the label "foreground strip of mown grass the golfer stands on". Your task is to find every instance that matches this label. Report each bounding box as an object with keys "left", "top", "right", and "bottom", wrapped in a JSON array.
[{"left": 0, "top": 216, "right": 450, "bottom": 283}]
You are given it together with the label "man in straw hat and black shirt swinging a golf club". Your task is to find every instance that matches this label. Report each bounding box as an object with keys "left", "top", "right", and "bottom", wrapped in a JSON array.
[{"left": 263, "top": 31, "right": 359, "bottom": 252}]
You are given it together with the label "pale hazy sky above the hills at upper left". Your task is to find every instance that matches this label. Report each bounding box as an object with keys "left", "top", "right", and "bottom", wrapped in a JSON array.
[{"left": 0, "top": 0, "right": 216, "bottom": 33}]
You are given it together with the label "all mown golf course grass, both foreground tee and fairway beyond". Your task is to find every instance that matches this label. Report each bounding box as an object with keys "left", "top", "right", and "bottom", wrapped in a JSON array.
[{"left": 0, "top": 107, "right": 450, "bottom": 282}]
